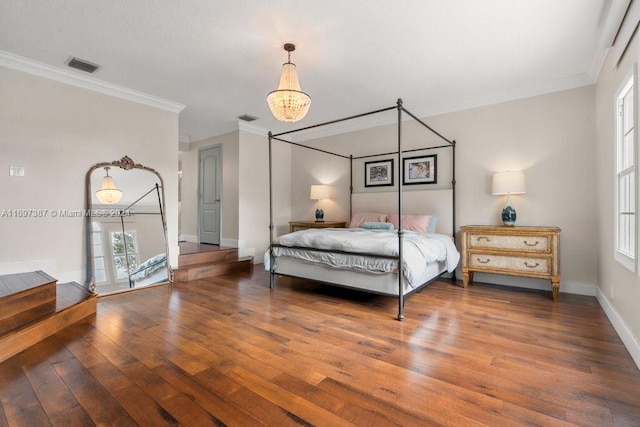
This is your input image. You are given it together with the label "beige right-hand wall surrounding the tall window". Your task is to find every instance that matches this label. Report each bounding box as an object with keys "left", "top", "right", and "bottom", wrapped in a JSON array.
[{"left": 594, "top": 31, "right": 640, "bottom": 366}]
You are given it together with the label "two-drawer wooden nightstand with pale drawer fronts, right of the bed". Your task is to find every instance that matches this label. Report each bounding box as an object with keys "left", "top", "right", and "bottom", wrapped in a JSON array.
[{"left": 460, "top": 225, "right": 560, "bottom": 301}]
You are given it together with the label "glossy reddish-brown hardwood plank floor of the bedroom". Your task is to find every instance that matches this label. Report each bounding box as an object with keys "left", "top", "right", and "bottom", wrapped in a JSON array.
[{"left": 0, "top": 268, "right": 640, "bottom": 427}]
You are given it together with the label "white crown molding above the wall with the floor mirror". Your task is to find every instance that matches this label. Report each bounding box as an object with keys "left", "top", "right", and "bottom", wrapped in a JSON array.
[{"left": 0, "top": 51, "right": 185, "bottom": 113}]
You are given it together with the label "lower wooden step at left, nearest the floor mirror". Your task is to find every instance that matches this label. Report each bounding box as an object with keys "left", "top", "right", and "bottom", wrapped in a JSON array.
[{"left": 0, "top": 282, "right": 97, "bottom": 362}]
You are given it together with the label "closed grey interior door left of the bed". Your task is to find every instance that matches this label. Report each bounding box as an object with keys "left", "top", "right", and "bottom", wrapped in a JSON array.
[{"left": 198, "top": 146, "right": 222, "bottom": 245}]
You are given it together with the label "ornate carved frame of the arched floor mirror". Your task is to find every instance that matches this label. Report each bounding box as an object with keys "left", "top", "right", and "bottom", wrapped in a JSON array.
[{"left": 85, "top": 156, "right": 173, "bottom": 294}]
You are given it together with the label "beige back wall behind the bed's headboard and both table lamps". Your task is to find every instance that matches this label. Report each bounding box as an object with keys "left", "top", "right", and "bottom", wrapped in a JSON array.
[{"left": 292, "top": 86, "right": 598, "bottom": 295}]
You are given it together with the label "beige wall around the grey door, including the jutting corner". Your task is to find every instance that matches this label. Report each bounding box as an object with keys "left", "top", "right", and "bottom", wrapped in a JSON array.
[{"left": 181, "top": 130, "right": 291, "bottom": 262}]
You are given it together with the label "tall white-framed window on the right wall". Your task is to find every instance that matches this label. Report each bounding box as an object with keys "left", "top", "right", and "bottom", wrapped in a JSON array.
[{"left": 615, "top": 75, "right": 636, "bottom": 271}]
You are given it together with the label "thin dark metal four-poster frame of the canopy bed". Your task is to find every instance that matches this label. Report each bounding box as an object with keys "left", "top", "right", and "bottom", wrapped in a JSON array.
[{"left": 268, "top": 98, "right": 456, "bottom": 320}]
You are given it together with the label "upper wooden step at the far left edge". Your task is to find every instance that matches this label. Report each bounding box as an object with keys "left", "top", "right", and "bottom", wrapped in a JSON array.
[{"left": 0, "top": 270, "right": 56, "bottom": 321}]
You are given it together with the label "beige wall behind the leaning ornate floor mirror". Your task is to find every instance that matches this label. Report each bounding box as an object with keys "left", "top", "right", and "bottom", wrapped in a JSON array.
[{"left": 0, "top": 67, "right": 178, "bottom": 282}]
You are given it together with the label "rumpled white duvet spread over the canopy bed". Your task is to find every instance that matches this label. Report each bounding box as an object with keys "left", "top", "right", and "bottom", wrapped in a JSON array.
[{"left": 264, "top": 228, "right": 460, "bottom": 288}]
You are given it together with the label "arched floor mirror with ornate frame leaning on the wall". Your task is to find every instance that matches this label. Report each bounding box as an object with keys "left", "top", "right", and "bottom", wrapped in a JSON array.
[{"left": 85, "top": 156, "right": 173, "bottom": 295}]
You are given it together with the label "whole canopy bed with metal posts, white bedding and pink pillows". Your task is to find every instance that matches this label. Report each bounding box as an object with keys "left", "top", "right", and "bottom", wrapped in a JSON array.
[{"left": 265, "top": 99, "right": 460, "bottom": 320}]
